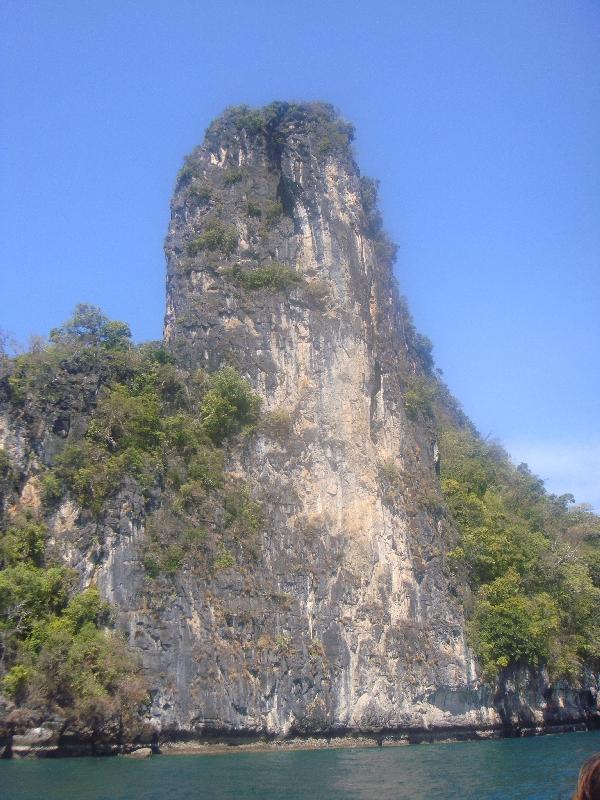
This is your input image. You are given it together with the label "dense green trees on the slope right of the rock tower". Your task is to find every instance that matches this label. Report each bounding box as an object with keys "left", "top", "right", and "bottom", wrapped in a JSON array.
[{"left": 440, "top": 418, "right": 600, "bottom": 680}]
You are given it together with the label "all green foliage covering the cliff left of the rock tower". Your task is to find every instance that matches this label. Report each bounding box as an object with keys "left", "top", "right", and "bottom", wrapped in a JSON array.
[{"left": 0, "top": 305, "right": 262, "bottom": 727}]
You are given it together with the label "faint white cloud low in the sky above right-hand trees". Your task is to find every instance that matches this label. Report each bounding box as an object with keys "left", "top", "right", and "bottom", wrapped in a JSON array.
[{"left": 505, "top": 439, "right": 600, "bottom": 512}]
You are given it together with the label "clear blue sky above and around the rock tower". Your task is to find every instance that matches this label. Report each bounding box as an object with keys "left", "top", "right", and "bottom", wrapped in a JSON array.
[{"left": 0, "top": 0, "right": 600, "bottom": 510}]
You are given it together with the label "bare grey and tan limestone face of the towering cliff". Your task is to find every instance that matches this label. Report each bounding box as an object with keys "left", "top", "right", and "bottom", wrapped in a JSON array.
[{"left": 0, "top": 104, "right": 596, "bottom": 746}]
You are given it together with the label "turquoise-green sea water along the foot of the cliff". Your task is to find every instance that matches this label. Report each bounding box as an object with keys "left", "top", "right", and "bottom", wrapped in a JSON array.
[{"left": 0, "top": 731, "right": 600, "bottom": 800}]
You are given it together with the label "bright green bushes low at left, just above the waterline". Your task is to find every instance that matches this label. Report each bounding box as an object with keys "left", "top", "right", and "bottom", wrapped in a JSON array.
[{"left": 0, "top": 514, "right": 146, "bottom": 730}]
